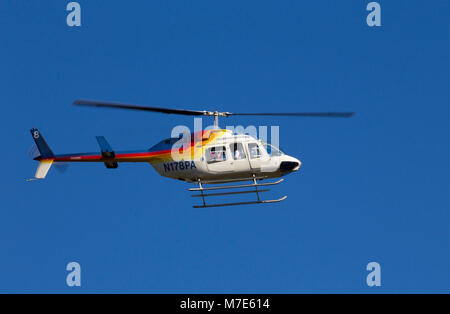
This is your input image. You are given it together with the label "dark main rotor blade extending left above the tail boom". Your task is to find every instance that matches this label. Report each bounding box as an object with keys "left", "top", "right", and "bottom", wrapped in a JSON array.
[{"left": 72, "top": 99, "right": 208, "bottom": 116}]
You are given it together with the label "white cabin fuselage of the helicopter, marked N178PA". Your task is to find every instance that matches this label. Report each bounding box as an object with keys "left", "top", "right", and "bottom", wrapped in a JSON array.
[{"left": 151, "top": 131, "right": 301, "bottom": 182}]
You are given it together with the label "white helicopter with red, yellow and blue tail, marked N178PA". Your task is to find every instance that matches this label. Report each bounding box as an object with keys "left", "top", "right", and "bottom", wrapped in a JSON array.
[{"left": 28, "top": 99, "right": 355, "bottom": 208}]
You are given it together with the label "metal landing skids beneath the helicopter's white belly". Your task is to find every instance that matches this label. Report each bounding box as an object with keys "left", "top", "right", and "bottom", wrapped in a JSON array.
[{"left": 189, "top": 175, "right": 287, "bottom": 208}]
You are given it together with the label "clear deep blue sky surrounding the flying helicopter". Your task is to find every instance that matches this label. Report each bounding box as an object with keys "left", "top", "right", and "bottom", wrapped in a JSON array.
[{"left": 0, "top": 0, "right": 450, "bottom": 293}]
